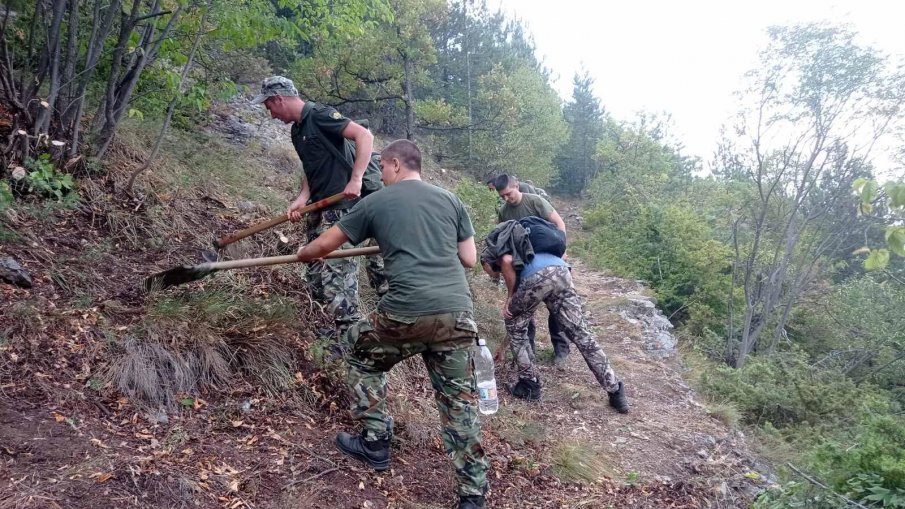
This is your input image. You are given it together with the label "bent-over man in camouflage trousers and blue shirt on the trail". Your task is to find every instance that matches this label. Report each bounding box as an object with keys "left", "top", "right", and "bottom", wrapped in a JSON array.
[{"left": 482, "top": 223, "right": 629, "bottom": 413}]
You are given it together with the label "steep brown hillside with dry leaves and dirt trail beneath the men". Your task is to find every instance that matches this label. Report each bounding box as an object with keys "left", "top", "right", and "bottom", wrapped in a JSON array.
[{"left": 0, "top": 101, "right": 766, "bottom": 509}]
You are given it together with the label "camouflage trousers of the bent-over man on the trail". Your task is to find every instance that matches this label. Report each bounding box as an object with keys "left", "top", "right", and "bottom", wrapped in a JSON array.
[{"left": 506, "top": 266, "right": 619, "bottom": 392}]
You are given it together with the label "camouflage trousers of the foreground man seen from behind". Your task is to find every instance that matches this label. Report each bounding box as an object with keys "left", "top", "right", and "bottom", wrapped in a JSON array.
[{"left": 346, "top": 311, "right": 489, "bottom": 495}]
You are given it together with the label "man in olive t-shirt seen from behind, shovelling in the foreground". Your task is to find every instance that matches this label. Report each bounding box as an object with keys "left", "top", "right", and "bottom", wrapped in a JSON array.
[{"left": 298, "top": 140, "right": 488, "bottom": 509}]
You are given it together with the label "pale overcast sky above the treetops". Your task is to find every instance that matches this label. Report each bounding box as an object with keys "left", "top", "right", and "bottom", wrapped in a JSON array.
[{"left": 488, "top": 0, "right": 905, "bottom": 164}]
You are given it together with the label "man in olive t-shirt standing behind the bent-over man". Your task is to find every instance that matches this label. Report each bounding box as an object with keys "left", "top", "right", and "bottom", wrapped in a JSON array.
[{"left": 484, "top": 174, "right": 569, "bottom": 366}]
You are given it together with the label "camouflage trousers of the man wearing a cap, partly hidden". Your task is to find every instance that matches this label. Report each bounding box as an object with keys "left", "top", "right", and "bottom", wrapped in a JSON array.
[{"left": 305, "top": 209, "right": 388, "bottom": 338}]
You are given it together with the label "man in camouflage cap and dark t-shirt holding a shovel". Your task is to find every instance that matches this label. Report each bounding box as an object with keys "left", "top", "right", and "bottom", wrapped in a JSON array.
[{"left": 252, "top": 76, "right": 387, "bottom": 338}]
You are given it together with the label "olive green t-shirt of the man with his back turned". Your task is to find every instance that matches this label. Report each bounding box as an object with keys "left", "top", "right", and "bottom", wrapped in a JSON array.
[{"left": 337, "top": 180, "right": 474, "bottom": 316}]
